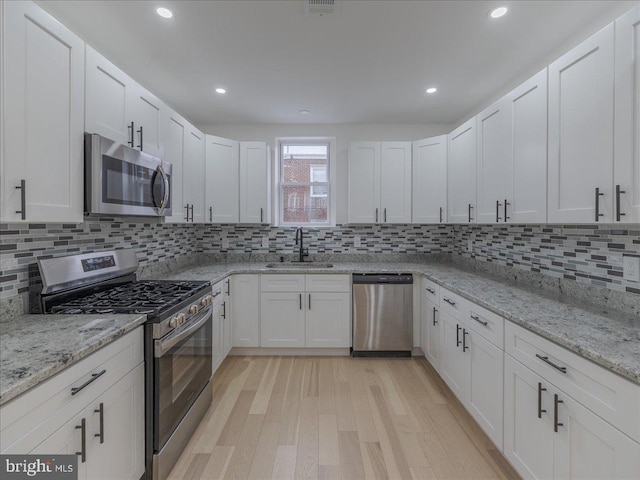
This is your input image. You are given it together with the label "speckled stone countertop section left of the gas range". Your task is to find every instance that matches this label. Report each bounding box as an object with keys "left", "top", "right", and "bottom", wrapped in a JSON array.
[{"left": 0, "top": 315, "right": 147, "bottom": 405}]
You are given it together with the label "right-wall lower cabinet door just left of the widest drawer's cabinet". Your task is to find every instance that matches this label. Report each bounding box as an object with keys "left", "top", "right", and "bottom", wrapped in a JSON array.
[{"left": 465, "top": 330, "right": 504, "bottom": 451}]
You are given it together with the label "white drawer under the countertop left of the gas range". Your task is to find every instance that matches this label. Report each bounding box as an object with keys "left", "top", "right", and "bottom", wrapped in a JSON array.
[{"left": 0, "top": 326, "right": 144, "bottom": 453}]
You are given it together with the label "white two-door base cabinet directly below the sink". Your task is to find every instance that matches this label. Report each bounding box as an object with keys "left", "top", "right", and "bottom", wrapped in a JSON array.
[{"left": 260, "top": 274, "right": 351, "bottom": 348}]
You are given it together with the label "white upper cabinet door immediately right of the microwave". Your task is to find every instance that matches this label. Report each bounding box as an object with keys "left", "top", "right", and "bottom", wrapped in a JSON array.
[{"left": 164, "top": 111, "right": 189, "bottom": 223}]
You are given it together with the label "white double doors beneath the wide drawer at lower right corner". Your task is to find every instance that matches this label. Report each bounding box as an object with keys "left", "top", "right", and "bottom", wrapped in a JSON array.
[{"left": 504, "top": 355, "right": 640, "bottom": 479}]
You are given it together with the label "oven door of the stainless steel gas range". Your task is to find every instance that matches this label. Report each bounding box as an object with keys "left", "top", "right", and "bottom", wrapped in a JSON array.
[{"left": 153, "top": 307, "right": 213, "bottom": 452}]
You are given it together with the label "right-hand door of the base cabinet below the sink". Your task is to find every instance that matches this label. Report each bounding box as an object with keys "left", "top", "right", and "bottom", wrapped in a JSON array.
[{"left": 303, "top": 292, "right": 351, "bottom": 348}]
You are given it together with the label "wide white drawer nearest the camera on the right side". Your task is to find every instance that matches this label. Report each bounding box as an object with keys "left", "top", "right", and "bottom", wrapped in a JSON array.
[{"left": 505, "top": 321, "right": 640, "bottom": 441}]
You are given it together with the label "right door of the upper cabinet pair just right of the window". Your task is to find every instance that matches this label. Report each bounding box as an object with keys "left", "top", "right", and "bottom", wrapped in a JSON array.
[{"left": 380, "top": 142, "right": 411, "bottom": 223}]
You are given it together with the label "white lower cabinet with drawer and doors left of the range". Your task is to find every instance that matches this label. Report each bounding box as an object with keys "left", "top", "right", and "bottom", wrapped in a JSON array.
[{"left": 0, "top": 327, "right": 145, "bottom": 480}]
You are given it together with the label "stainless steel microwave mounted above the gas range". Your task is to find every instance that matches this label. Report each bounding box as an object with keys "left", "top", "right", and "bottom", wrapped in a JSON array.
[{"left": 84, "top": 133, "right": 172, "bottom": 217}]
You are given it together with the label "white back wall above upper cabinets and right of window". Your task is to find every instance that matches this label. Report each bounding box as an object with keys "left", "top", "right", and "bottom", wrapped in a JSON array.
[{"left": 198, "top": 124, "right": 452, "bottom": 224}]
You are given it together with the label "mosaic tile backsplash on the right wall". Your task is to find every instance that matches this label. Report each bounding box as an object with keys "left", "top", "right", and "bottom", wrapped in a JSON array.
[{"left": 451, "top": 224, "right": 640, "bottom": 294}]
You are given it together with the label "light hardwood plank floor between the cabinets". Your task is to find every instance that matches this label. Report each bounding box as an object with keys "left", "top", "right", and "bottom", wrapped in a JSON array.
[{"left": 170, "top": 356, "right": 519, "bottom": 480}]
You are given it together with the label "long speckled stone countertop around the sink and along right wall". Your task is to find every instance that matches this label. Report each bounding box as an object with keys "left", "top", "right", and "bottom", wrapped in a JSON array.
[{"left": 146, "top": 263, "right": 640, "bottom": 384}]
